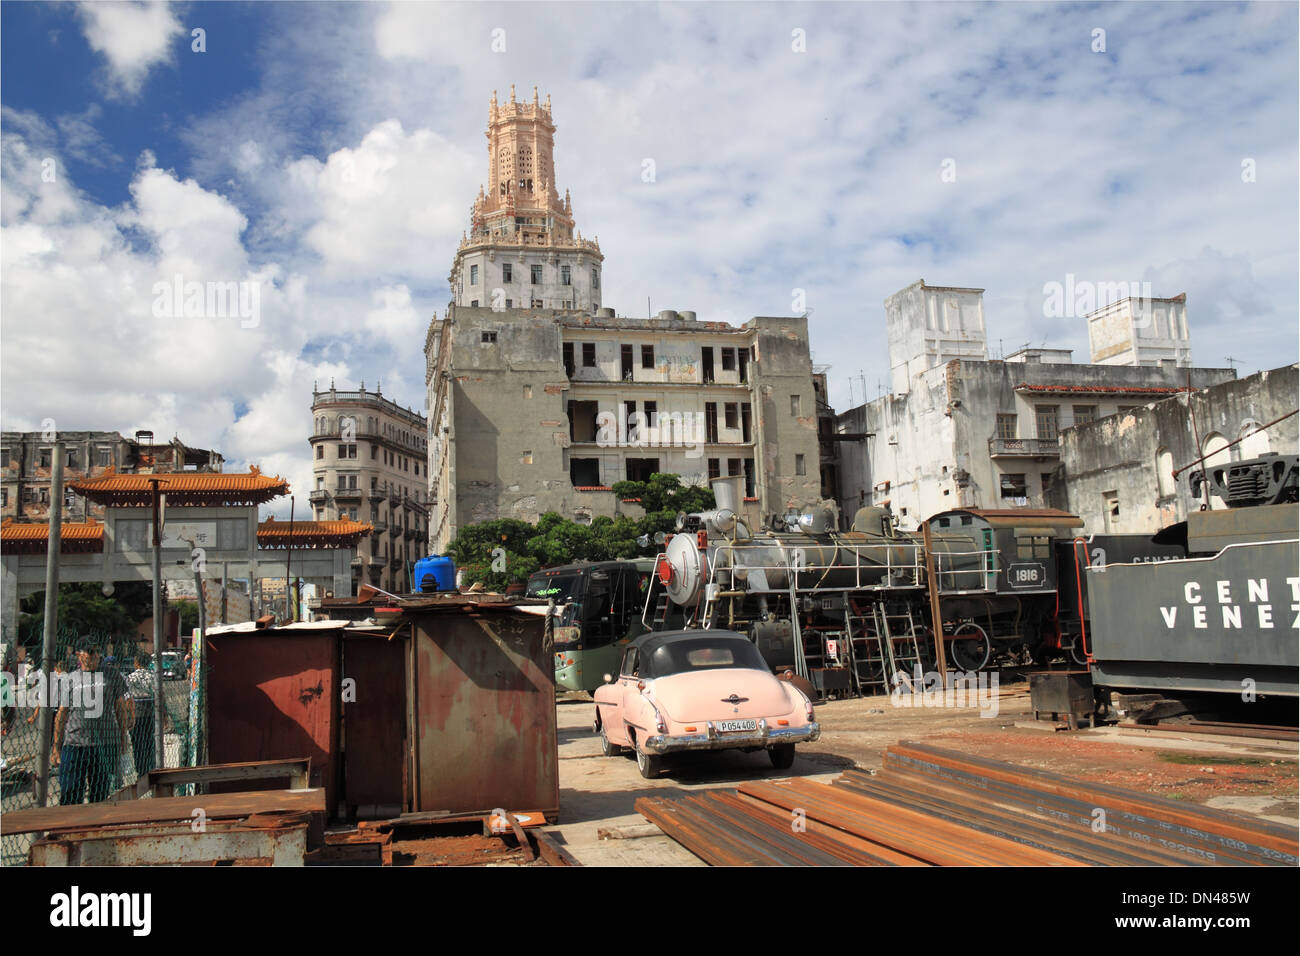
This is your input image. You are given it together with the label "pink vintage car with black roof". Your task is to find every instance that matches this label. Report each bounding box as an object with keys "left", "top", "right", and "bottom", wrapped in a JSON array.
[{"left": 595, "top": 630, "right": 822, "bottom": 777}]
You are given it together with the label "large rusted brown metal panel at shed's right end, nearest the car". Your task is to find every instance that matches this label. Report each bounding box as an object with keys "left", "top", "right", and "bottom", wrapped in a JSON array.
[{"left": 408, "top": 606, "right": 559, "bottom": 819}]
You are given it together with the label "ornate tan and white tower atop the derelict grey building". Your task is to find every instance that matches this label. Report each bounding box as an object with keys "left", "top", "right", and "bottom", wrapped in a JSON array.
[{"left": 450, "top": 86, "right": 605, "bottom": 312}]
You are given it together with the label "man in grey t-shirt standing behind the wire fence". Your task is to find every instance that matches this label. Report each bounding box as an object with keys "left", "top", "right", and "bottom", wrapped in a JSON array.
[{"left": 55, "top": 644, "right": 130, "bottom": 805}]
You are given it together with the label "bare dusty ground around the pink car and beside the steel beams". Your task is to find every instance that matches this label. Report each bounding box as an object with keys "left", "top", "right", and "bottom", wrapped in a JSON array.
[{"left": 550, "top": 682, "right": 1300, "bottom": 866}]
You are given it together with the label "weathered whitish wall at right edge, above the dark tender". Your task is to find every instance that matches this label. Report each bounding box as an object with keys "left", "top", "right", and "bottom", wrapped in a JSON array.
[{"left": 1052, "top": 365, "right": 1300, "bottom": 533}]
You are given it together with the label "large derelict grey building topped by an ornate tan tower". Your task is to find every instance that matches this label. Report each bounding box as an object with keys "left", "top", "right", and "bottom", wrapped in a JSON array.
[{"left": 425, "top": 91, "right": 820, "bottom": 553}]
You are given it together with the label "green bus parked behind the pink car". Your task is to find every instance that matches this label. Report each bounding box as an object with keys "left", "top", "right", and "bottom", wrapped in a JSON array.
[{"left": 528, "top": 558, "right": 654, "bottom": 693}]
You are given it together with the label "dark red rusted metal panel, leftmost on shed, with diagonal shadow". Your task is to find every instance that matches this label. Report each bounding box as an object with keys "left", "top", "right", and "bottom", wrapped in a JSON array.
[{"left": 204, "top": 630, "right": 341, "bottom": 814}]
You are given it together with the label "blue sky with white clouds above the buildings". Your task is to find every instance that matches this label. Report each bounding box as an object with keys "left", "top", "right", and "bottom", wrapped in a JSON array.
[{"left": 0, "top": 3, "right": 1300, "bottom": 515}]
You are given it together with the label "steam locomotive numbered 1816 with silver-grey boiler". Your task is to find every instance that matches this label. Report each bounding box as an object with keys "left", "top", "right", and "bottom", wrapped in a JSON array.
[{"left": 642, "top": 463, "right": 1295, "bottom": 697}]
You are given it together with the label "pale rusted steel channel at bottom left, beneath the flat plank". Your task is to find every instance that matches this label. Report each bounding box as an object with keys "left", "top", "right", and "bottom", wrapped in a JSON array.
[{"left": 29, "top": 816, "right": 307, "bottom": 866}]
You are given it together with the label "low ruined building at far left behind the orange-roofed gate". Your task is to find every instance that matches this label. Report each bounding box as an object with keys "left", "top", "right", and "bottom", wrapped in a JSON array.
[{"left": 0, "top": 429, "right": 225, "bottom": 523}]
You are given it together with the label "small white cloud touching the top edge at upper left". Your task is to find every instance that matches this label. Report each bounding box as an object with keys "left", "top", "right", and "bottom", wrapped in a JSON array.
[{"left": 78, "top": 0, "right": 185, "bottom": 98}]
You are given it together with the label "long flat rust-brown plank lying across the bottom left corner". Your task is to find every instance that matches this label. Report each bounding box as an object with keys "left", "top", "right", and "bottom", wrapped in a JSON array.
[{"left": 3, "top": 787, "right": 325, "bottom": 836}]
